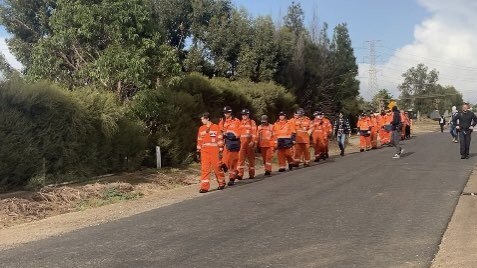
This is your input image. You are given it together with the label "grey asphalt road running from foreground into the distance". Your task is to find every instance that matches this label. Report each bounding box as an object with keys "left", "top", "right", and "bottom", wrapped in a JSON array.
[{"left": 0, "top": 133, "right": 477, "bottom": 267}]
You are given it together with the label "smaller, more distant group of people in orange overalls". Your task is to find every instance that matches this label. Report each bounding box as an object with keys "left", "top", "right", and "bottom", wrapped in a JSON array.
[{"left": 357, "top": 110, "right": 412, "bottom": 152}]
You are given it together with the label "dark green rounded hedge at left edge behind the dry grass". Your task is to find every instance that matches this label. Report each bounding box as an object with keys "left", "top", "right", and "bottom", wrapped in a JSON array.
[{"left": 0, "top": 83, "right": 146, "bottom": 189}]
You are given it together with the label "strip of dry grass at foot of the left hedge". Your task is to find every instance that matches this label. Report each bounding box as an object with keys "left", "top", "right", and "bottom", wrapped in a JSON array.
[{"left": 0, "top": 168, "right": 198, "bottom": 229}]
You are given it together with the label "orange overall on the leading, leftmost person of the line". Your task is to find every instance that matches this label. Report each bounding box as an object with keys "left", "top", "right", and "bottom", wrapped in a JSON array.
[{"left": 197, "top": 123, "right": 225, "bottom": 191}]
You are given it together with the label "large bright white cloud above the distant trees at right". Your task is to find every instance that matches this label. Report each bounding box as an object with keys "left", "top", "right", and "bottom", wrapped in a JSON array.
[{"left": 360, "top": 0, "right": 477, "bottom": 103}]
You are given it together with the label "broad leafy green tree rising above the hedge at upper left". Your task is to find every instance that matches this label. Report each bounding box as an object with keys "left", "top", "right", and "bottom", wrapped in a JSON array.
[{"left": 27, "top": 0, "right": 180, "bottom": 99}]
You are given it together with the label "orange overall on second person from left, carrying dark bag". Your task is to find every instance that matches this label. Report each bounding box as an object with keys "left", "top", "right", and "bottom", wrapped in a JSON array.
[{"left": 219, "top": 118, "right": 240, "bottom": 181}]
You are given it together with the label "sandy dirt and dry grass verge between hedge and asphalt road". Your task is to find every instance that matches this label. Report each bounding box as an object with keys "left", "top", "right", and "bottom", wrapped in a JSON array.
[{"left": 0, "top": 120, "right": 439, "bottom": 249}]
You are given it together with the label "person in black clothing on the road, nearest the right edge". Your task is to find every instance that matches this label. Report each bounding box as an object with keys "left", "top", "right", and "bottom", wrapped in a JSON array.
[{"left": 453, "top": 103, "right": 477, "bottom": 159}]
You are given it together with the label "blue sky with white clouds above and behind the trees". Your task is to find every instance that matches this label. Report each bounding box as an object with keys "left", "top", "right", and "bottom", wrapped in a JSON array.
[{"left": 0, "top": 0, "right": 477, "bottom": 103}]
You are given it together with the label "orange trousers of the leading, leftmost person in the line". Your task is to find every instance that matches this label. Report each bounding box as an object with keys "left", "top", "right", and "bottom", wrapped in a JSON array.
[{"left": 200, "top": 147, "right": 225, "bottom": 191}]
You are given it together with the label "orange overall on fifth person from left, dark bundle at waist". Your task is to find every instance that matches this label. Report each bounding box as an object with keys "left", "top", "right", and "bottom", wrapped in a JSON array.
[{"left": 273, "top": 120, "right": 295, "bottom": 170}]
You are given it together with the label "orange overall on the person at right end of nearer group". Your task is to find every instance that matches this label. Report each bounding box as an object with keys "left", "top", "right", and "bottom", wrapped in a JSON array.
[{"left": 310, "top": 118, "right": 333, "bottom": 159}]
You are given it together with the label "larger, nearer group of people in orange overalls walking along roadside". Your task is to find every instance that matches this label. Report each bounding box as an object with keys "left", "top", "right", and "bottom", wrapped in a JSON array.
[{"left": 193, "top": 106, "right": 334, "bottom": 193}]
